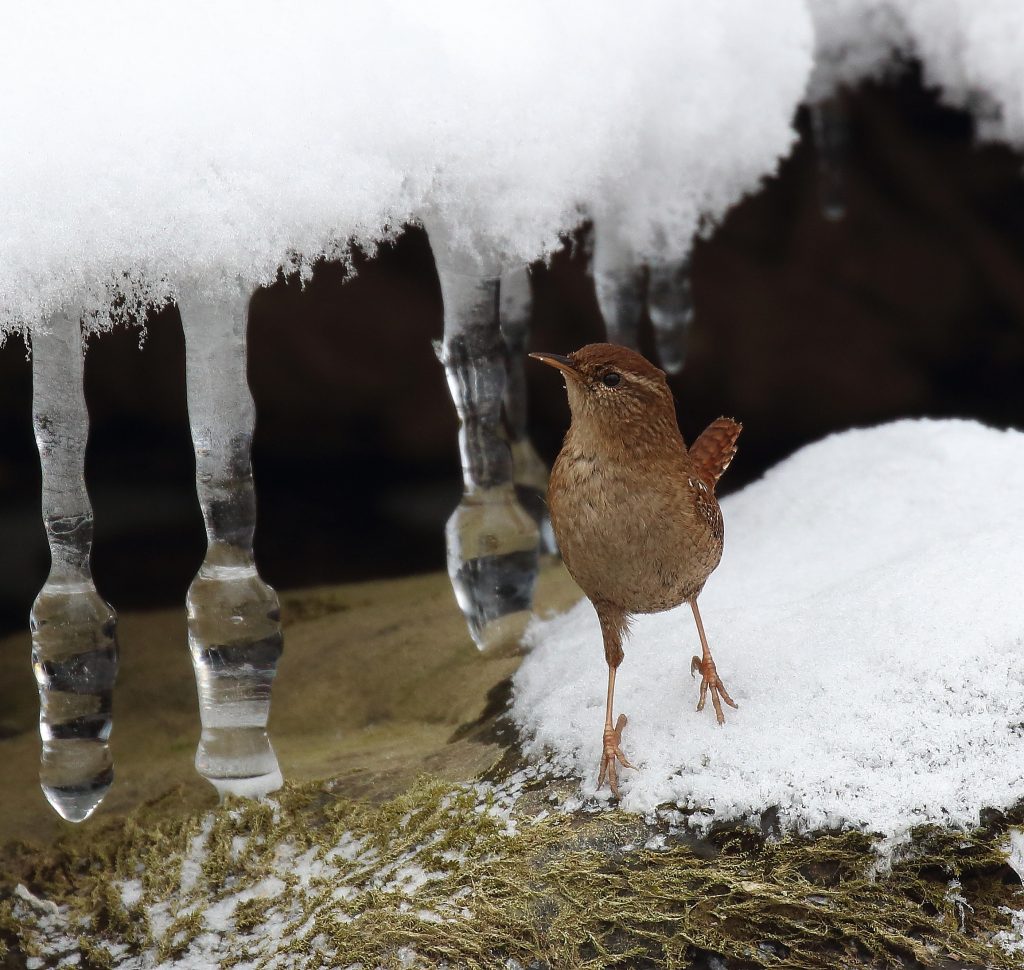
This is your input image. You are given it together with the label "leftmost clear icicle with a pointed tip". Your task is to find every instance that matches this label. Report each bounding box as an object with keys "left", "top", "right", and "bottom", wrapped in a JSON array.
[{"left": 31, "top": 313, "right": 118, "bottom": 821}]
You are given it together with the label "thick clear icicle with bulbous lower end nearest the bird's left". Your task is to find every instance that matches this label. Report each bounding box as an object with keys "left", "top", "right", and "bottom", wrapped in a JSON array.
[{"left": 427, "top": 223, "right": 540, "bottom": 650}]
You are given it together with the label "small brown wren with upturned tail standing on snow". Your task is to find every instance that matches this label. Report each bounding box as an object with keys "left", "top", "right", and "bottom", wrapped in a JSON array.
[{"left": 529, "top": 343, "right": 742, "bottom": 799}]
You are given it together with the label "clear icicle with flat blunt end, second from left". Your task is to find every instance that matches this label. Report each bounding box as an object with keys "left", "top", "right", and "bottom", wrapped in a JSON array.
[{"left": 178, "top": 288, "right": 283, "bottom": 796}]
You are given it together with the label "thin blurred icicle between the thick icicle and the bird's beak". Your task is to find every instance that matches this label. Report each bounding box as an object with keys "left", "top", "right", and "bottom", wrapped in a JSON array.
[{"left": 498, "top": 266, "right": 558, "bottom": 553}]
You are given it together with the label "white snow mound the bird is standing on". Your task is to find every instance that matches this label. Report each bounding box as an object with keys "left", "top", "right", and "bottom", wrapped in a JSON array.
[{"left": 513, "top": 421, "right": 1024, "bottom": 835}]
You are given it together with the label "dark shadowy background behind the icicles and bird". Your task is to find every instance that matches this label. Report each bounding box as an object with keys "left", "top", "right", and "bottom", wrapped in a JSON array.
[{"left": 0, "top": 71, "right": 1024, "bottom": 631}]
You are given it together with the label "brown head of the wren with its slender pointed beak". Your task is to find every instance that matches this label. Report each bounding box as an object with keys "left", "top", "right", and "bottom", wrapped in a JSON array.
[{"left": 530, "top": 343, "right": 675, "bottom": 426}]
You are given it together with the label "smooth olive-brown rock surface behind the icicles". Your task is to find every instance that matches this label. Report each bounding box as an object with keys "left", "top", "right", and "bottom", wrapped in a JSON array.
[{"left": 0, "top": 565, "right": 580, "bottom": 844}]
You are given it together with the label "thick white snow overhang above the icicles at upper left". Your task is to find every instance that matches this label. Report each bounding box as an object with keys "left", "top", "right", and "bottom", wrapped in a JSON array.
[{"left": 0, "top": 0, "right": 811, "bottom": 336}]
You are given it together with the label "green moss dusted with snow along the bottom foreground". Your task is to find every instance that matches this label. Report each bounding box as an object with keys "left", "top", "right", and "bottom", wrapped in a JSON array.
[{"left": 0, "top": 778, "right": 1024, "bottom": 970}]
